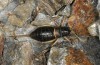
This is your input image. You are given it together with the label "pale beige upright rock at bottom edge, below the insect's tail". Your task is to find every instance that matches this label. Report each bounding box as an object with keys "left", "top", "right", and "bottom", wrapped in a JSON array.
[{"left": 12, "top": 42, "right": 32, "bottom": 65}]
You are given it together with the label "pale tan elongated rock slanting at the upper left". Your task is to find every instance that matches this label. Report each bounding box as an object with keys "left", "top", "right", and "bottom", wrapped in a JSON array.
[{"left": 8, "top": 0, "right": 35, "bottom": 27}]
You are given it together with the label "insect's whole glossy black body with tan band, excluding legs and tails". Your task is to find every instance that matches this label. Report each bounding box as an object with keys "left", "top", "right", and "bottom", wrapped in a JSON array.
[{"left": 30, "top": 26, "right": 70, "bottom": 42}]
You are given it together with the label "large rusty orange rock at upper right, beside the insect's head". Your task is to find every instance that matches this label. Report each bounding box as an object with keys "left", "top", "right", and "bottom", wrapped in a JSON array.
[{"left": 68, "top": 0, "right": 96, "bottom": 36}]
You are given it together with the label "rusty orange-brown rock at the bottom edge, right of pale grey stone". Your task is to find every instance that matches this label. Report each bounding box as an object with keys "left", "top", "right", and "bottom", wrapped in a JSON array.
[{"left": 66, "top": 48, "right": 93, "bottom": 65}]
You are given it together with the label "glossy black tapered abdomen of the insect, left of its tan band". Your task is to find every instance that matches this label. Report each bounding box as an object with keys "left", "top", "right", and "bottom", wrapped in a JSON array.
[{"left": 30, "top": 27, "right": 55, "bottom": 42}]
